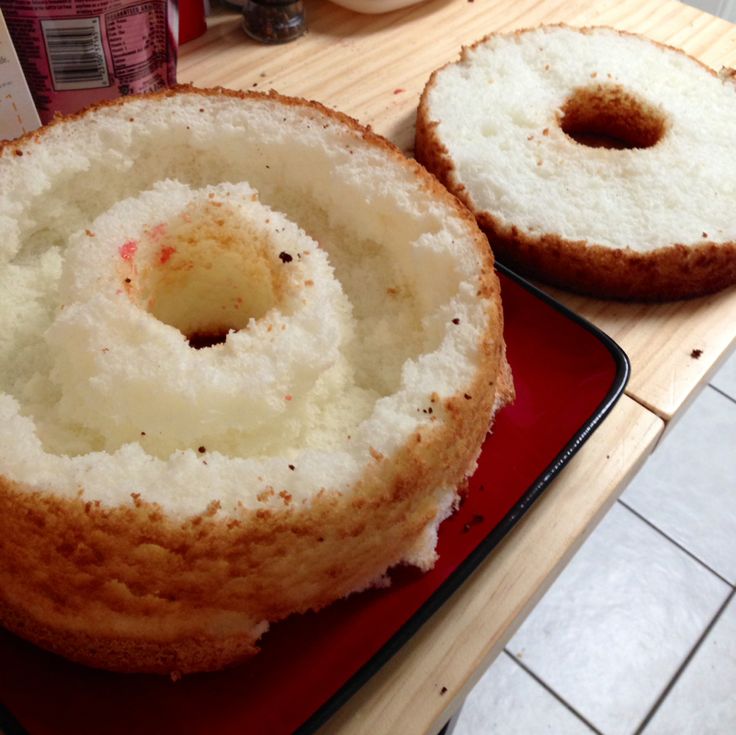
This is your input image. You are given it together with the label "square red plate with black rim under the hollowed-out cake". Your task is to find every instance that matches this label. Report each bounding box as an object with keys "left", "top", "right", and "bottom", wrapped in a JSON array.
[{"left": 0, "top": 266, "right": 629, "bottom": 735}]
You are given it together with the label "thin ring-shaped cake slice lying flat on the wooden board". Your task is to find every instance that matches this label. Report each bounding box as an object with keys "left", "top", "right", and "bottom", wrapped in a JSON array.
[{"left": 416, "top": 26, "right": 736, "bottom": 300}]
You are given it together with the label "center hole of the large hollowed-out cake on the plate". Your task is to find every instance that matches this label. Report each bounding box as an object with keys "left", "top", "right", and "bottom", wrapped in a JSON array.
[{"left": 137, "top": 201, "right": 288, "bottom": 349}]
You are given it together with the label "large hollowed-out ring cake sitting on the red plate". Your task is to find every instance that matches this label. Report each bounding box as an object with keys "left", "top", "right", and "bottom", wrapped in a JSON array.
[{"left": 0, "top": 88, "right": 512, "bottom": 673}]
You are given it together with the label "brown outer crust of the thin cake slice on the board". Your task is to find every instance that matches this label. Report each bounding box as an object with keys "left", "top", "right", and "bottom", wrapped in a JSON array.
[{"left": 415, "top": 23, "right": 736, "bottom": 301}]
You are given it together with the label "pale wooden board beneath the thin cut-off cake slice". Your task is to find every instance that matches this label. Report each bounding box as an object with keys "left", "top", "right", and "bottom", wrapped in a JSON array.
[{"left": 179, "top": 0, "right": 736, "bottom": 421}]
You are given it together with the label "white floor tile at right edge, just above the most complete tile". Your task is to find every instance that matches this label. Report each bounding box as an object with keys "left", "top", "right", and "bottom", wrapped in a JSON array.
[{"left": 621, "top": 387, "right": 736, "bottom": 584}]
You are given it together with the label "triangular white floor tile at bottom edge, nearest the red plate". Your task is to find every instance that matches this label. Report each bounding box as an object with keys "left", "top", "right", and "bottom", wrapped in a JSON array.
[{"left": 453, "top": 653, "right": 593, "bottom": 735}]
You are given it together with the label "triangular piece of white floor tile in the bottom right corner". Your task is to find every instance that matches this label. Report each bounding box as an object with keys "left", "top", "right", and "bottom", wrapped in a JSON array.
[{"left": 644, "top": 599, "right": 736, "bottom": 735}]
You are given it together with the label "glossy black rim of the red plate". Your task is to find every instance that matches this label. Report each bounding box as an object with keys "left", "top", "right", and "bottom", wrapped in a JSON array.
[{"left": 0, "top": 262, "right": 631, "bottom": 735}]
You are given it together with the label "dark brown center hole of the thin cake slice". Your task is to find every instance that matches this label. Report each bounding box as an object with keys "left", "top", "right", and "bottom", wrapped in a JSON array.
[{"left": 560, "top": 84, "right": 667, "bottom": 149}]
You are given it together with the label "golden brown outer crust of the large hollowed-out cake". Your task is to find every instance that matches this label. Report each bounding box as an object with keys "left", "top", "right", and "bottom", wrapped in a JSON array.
[{"left": 0, "top": 88, "right": 513, "bottom": 674}]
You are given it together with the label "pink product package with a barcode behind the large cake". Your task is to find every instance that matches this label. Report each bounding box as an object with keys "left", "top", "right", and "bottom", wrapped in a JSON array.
[{"left": 0, "top": 0, "right": 178, "bottom": 122}]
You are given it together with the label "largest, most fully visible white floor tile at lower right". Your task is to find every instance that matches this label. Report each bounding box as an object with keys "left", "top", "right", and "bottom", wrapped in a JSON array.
[{"left": 509, "top": 504, "right": 731, "bottom": 735}]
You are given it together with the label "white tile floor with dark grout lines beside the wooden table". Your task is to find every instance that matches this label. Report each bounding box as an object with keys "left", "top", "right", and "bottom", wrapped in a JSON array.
[{"left": 453, "top": 354, "right": 736, "bottom": 735}]
